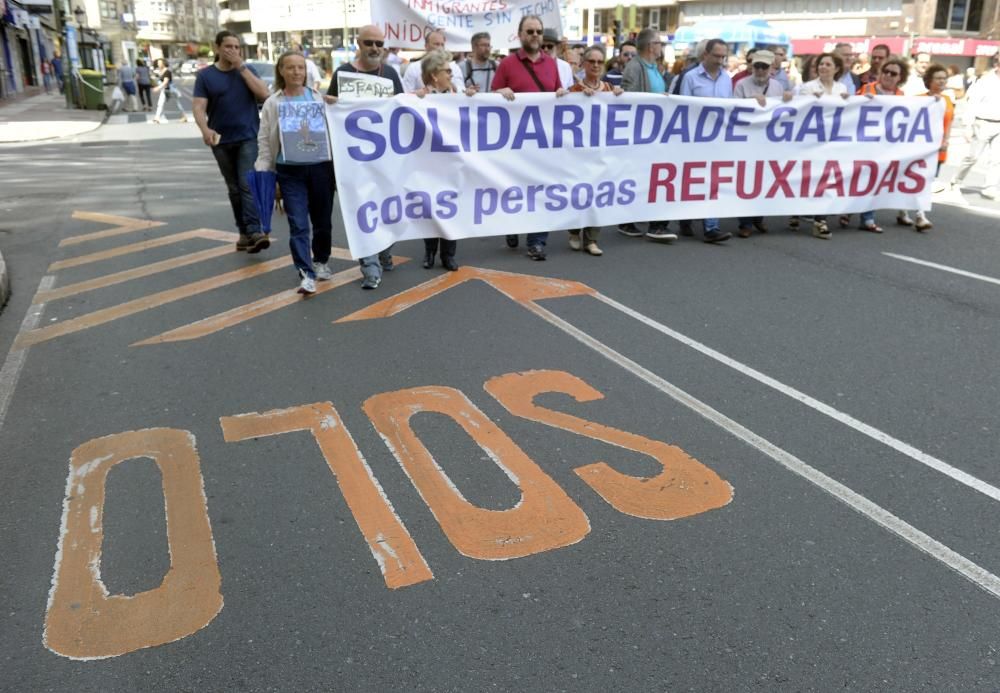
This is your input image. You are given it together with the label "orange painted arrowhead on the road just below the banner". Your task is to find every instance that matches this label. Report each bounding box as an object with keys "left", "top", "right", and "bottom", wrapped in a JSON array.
[{"left": 334, "top": 267, "right": 596, "bottom": 323}]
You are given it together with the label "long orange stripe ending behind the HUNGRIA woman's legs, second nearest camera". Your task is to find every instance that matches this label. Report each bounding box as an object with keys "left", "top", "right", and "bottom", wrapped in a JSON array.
[{"left": 13, "top": 255, "right": 292, "bottom": 349}]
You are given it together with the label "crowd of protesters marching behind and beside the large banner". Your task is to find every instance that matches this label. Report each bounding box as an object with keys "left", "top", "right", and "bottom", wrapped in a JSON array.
[{"left": 194, "top": 24, "right": 1000, "bottom": 294}]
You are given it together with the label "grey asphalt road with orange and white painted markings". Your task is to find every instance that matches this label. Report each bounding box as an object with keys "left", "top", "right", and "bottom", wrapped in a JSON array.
[{"left": 0, "top": 105, "right": 1000, "bottom": 691}]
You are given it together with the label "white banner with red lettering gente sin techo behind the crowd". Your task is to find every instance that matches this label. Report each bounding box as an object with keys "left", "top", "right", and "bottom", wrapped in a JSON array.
[{"left": 371, "top": 0, "right": 561, "bottom": 51}]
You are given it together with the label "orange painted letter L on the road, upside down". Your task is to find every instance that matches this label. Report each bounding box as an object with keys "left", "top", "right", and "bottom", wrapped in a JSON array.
[{"left": 219, "top": 402, "right": 434, "bottom": 589}]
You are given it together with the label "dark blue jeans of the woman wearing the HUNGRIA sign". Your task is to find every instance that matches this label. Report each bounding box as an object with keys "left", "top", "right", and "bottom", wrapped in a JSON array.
[{"left": 277, "top": 161, "right": 334, "bottom": 279}]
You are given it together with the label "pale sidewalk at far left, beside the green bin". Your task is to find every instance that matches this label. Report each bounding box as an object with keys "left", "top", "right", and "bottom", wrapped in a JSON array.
[{"left": 0, "top": 90, "right": 106, "bottom": 144}]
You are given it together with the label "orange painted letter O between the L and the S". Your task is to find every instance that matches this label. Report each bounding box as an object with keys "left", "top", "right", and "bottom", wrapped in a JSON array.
[{"left": 364, "top": 386, "right": 590, "bottom": 560}]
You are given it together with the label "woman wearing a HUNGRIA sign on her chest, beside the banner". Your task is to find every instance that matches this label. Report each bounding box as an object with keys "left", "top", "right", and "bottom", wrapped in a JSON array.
[{"left": 254, "top": 51, "right": 338, "bottom": 296}]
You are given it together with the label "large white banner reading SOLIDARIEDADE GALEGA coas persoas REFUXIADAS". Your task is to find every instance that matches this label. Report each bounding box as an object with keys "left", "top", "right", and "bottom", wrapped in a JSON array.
[{"left": 327, "top": 94, "right": 944, "bottom": 257}]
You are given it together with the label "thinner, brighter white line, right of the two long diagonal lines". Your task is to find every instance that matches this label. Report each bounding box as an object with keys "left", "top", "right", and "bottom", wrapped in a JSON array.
[{"left": 594, "top": 293, "right": 1000, "bottom": 501}]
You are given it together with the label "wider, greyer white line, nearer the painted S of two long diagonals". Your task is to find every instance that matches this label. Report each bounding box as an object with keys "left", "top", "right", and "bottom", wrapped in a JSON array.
[{"left": 522, "top": 302, "right": 1000, "bottom": 598}]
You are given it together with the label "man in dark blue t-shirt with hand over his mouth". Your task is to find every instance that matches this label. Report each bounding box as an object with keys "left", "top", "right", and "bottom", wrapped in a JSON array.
[{"left": 193, "top": 31, "right": 271, "bottom": 253}]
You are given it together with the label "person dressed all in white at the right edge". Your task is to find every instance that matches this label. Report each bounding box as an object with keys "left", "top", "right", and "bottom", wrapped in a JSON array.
[{"left": 951, "top": 52, "right": 1000, "bottom": 200}]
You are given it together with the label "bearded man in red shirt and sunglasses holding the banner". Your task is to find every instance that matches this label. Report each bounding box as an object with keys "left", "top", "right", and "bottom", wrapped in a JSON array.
[{"left": 491, "top": 14, "right": 566, "bottom": 260}]
